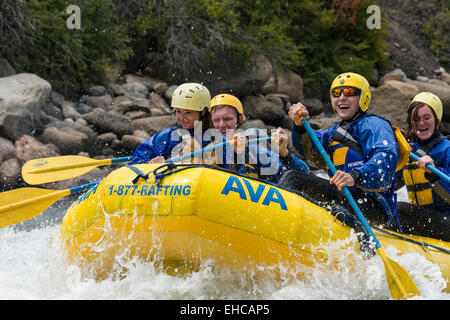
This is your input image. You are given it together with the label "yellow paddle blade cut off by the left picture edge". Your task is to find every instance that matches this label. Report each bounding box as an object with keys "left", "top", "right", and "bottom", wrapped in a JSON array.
[{"left": 0, "top": 188, "right": 70, "bottom": 228}]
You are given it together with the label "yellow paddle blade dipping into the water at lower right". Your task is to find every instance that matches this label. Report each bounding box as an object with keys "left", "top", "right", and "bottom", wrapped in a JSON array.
[{"left": 377, "top": 248, "right": 420, "bottom": 300}]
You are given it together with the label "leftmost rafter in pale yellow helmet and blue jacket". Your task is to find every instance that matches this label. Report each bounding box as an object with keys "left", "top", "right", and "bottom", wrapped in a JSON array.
[{"left": 129, "top": 83, "right": 217, "bottom": 165}]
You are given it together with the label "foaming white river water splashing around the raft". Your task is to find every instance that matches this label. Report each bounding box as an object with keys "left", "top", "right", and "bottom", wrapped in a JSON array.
[{"left": 0, "top": 186, "right": 450, "bottom": 300}]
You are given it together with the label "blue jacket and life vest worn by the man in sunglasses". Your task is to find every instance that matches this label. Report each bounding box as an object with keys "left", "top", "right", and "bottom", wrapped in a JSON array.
[{"left": 292, "top": 113, "right": 399, "bottom": 226}]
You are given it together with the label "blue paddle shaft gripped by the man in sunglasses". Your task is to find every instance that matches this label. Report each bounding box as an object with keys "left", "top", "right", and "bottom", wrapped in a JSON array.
[{"left": 302, "top": 118, "right": 381, "bottom": 249}]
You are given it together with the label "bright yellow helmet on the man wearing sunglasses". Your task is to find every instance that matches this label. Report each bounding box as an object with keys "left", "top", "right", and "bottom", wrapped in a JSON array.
[{"left": 330, "top": 72, "right": 371, "bottom": 111}]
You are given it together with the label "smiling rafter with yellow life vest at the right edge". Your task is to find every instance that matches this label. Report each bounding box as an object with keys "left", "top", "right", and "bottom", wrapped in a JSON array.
[{"left": 398, "top": 92, "right": 450, "bottom": 241}]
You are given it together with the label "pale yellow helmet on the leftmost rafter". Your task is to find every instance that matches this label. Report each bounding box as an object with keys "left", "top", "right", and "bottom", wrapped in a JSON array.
[{"left": 171, "top": 83, "right": 211, "bottom": 111}]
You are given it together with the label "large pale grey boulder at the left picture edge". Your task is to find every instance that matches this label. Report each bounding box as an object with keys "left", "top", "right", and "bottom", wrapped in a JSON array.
[{"left": 0, "top": 73, "right": 52, "bottom": 141}]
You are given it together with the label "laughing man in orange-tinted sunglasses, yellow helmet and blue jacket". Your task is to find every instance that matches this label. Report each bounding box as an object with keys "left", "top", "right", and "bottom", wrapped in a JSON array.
[{"left": 289, "top": 72, "right": 401, "bottom": 230}]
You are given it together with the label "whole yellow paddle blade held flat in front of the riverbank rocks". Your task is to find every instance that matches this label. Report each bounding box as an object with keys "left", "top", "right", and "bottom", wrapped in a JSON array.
[{"left": 22, "top": 156, "right": 111, "bottom": 185}]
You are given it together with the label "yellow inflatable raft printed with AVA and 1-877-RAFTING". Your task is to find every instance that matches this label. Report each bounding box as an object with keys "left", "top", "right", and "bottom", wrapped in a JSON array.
[{"left": 61, "top": 164, "right": 450, "bottom": 291}]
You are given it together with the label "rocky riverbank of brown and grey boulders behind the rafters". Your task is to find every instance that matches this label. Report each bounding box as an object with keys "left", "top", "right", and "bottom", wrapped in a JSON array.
[{"left": 0, "top": 57, "right": 450, "bottom": 191}]
